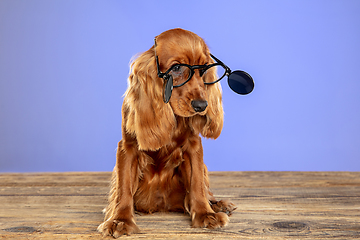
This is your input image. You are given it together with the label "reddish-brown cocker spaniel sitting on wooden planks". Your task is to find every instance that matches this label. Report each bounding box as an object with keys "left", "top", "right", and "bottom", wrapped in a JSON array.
[{"left": 98, "top": 28, "right": 236, "bottom": 238}]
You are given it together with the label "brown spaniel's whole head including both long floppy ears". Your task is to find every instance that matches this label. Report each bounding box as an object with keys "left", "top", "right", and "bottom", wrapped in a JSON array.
[{"left": 123, "top": 29, "right": 223, "bottom": 150}]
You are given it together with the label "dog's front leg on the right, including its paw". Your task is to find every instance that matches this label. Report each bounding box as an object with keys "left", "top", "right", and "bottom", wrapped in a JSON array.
[{"left": 182, "top": 136, "right": 229, "bottom": 228}]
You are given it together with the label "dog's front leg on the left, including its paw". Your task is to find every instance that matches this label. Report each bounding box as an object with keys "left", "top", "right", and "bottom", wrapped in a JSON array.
[{"left": 98, "top": 141, "right": 139, "bottom": 238}]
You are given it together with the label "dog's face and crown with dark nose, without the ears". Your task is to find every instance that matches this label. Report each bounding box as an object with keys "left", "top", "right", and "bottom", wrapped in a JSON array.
[{"left": 156, "top": 29, "right": 215, "bottom": 117}]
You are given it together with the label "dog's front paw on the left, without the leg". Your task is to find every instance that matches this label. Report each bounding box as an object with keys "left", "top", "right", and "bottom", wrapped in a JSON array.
[{"left": 98, "top": 219, "right": 140, "bottom": 238}]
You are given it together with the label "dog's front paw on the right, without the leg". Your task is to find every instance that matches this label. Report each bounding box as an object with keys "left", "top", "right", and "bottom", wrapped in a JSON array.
[{"left": 192, "top": 212, "right": 229, "bottom": 229}]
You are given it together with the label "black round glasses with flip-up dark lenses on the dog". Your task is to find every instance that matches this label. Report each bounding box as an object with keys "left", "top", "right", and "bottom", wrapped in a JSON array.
[{"left": 154, "top": 39, "right": 254, "bottom": 103}]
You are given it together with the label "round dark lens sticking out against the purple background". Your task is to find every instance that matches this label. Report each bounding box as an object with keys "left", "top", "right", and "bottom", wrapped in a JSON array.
[{"left": 228, "top": 70, "right": 254, "bottom": 95}]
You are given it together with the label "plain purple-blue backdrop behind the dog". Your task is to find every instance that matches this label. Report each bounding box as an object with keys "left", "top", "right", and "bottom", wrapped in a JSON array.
[{"left": 0, "top": 0, "right": 360, "bottom": 172}]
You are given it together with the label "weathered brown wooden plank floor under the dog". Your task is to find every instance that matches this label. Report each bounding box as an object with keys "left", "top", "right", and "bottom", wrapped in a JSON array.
[{"left": 0, "top": 172, "right": 360, "bottom": 240}]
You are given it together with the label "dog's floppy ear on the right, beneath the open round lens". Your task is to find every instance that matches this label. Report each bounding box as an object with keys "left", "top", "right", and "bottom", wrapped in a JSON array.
[{"left": 191, "top": 70, "right": 224, "bottom": 139}]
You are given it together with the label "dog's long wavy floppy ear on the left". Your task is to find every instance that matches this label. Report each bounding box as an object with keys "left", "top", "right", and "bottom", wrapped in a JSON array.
[{"left": 123, "top": 47, "right": 176, "bottom": 150}]
